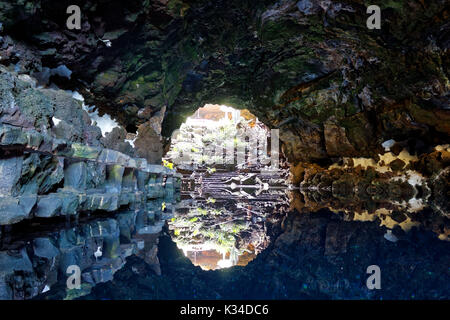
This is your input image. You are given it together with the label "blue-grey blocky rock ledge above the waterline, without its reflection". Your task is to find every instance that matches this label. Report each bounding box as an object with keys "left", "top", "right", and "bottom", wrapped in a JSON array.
[{"left": 0, "top": 64, "right": 179, "bottom": 225}]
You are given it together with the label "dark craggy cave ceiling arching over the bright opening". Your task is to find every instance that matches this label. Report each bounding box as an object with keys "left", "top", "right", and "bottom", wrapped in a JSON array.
[{"left": 0, "top": 0, "right": 444, "bottom": 163}]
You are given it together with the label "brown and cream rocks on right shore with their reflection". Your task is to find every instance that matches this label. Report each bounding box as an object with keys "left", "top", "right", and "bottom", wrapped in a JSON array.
[{"left": 291, "top": 161, "right": 450, "bottom": 241}]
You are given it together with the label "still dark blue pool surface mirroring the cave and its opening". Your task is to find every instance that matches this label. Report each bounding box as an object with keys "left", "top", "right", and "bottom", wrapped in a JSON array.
[{"left": 0, "top": 173, "right": 449, "bottom": 299}]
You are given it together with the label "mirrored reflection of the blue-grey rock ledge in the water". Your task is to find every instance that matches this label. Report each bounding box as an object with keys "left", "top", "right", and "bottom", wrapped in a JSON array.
[{"left": 0, "top": 200, "right": 168, "bottom": 299}]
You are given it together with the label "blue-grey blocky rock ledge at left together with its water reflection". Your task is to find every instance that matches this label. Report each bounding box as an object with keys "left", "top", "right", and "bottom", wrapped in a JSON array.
[{"left": 0, "top": 67, "right": 180, "bottom": 299}]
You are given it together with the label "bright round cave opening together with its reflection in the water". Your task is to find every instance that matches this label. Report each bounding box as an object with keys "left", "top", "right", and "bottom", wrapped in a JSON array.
[{"left": 164, "top": 104, "right": 290, "bottom": 270}]
